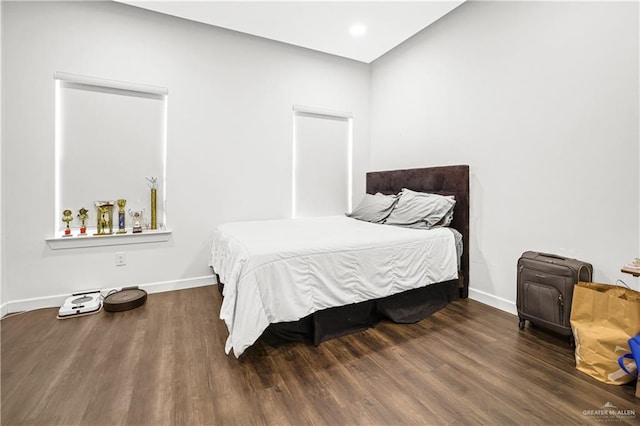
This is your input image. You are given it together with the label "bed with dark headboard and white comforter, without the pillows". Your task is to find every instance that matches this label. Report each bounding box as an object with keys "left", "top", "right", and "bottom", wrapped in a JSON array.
[{"left": 209, "top": 166, "right": 469, "bottom": 357}]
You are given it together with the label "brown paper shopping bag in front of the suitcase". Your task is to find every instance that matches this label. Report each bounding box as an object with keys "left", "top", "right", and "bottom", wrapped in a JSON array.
[{"left": 571, "top": 282, "right": 640, "bottom": 385}]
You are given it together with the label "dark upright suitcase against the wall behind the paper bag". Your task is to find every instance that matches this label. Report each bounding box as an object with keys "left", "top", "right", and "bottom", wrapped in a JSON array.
[{"left": 516, "top": 251, "right": 593, "bottom": 345}]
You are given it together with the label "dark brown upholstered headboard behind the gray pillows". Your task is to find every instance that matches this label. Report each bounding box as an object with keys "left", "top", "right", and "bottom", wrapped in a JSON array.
[{"left": 367, "top": 166, "right": 469, "bottom": 297}]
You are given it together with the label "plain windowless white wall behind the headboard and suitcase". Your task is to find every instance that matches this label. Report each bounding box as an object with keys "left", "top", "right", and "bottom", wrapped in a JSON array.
[{"left": 371, "top": 2, "right": 640, "bottom": 312}]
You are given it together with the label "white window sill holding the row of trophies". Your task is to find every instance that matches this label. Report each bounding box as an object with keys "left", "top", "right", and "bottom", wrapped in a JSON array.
[{"left": 46, "top": 230, "right": 171, "bottom": 250}]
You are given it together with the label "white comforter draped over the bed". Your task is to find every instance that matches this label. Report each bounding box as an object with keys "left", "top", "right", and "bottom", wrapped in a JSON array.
[{"left": 209, "top": 216, "right": 458, "bottom": 357}]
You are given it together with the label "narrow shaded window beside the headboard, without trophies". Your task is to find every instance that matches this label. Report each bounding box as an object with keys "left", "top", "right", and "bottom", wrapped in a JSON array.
[{"left": 292, "top": 106, "right": 353, "bottom": 217}]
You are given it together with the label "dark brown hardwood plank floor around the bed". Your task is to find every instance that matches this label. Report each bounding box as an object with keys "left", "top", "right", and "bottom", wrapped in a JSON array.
[{"left": 1, "top": 286, "right": 640, "bottom": 425}]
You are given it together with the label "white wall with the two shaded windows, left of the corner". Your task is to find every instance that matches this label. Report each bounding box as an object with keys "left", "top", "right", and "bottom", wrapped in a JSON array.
[{"left": 2, "top": 2, "right": 370, "bottom": 311}]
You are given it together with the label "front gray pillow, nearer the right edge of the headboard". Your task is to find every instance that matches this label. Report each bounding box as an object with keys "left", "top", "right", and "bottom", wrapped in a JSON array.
[{"left": 385, "top": 188, "right": 456, "bottom": 229}]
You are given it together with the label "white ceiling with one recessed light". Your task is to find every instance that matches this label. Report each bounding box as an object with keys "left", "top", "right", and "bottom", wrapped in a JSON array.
[{"left": 117, "top": 0, "right": 465, "bottom": 63}]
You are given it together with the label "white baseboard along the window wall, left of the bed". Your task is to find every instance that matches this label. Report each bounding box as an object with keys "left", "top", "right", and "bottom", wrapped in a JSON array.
[{"left": 0, "top": 275, "right": 216, "bottom": 317}]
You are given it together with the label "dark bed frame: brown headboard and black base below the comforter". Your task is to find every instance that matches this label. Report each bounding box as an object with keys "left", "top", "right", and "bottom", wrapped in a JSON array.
[{"left": 216, "top": 165, "right": 469, "bottom": 352}]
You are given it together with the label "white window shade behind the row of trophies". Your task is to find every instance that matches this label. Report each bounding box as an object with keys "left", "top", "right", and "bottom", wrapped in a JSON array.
[{"left": 55, "top": 73, "right": 167, "bottom": 235}]
